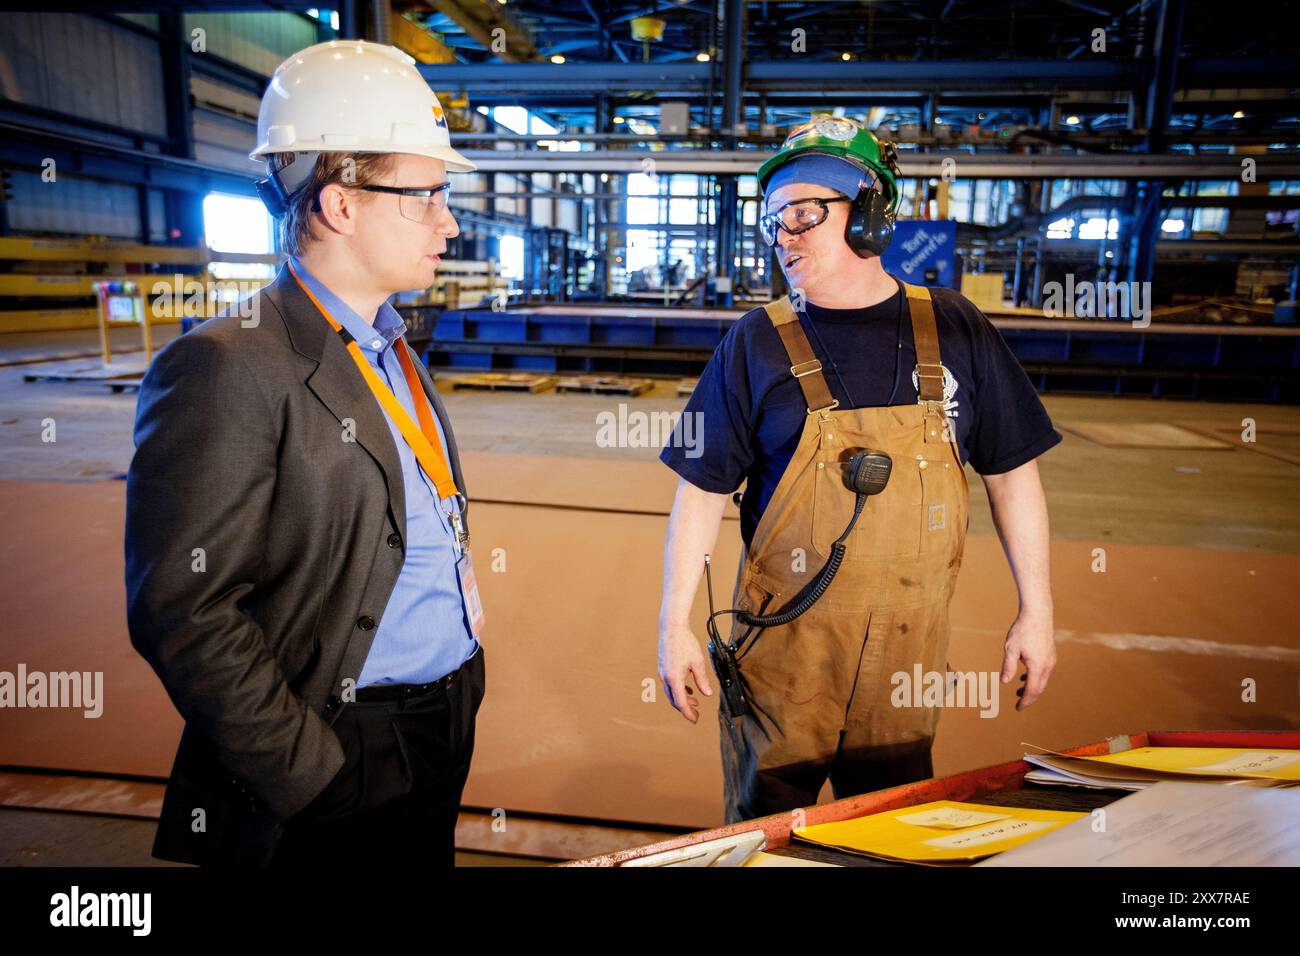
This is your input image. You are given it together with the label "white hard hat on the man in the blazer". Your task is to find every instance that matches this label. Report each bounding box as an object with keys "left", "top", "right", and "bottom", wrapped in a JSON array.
[{"left": 248, "top": 40, "right": 476, "bottom": 178}]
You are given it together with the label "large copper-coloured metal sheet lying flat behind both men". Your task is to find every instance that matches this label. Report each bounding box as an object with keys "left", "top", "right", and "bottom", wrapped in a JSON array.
[{"left": 0, "top": 468, "right": 1300, "bottom": 827}]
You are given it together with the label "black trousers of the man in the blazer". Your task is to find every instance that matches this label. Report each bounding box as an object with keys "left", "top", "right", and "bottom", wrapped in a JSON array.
[{"left": 272, "top": 646, "right": 484, "bottom": 866}]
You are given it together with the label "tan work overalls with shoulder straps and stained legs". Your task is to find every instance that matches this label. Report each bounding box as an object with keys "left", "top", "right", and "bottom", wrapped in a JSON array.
[{"left": 719, "top": 285, "right": 969, "bottom": 823}]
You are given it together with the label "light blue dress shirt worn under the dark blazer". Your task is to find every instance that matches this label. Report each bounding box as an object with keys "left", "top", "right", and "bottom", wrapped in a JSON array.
[{"left": 293, "top": 259, "right": 478, "bottom": 687}]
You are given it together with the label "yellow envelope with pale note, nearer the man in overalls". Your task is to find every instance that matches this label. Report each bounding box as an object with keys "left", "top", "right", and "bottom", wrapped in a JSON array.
[{"left": 794, "top": 800, "right": 1086, "bottom": 866}]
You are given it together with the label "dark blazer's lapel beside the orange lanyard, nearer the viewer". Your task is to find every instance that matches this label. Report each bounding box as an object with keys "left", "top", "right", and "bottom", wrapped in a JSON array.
[{"left": 273, "top": 267, "right": 406, "bottom": 532}]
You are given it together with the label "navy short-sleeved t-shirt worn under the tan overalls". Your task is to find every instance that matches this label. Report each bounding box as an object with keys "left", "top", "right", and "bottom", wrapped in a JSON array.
[{"left": 659, "top": 278, "right": 1061, "bottom": 548}]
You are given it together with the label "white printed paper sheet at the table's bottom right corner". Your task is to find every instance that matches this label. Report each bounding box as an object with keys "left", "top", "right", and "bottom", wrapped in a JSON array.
[{"left": 975, "top": 780, "right": 1300, "bottom": 866}]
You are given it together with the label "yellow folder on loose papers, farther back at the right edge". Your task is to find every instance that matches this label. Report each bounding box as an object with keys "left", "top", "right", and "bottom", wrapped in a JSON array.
[{"left": 1024, "top": 747, "right": 1300, "bottom": 790}]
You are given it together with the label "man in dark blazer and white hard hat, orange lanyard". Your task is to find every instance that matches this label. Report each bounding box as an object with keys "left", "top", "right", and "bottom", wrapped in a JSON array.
[{"left": 126, "top": 40, "right": 484, "bottom": 865}]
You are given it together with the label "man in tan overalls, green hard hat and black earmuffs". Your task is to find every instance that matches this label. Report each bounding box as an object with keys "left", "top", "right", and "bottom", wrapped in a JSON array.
[{"left": 659, "top": 118, "right": 1061, "bottom": 822}]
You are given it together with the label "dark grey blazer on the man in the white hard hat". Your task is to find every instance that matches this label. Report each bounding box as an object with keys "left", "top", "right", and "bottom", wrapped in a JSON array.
[{"left": 125, "top": 267, "right": 468, "bottom": 864}]
